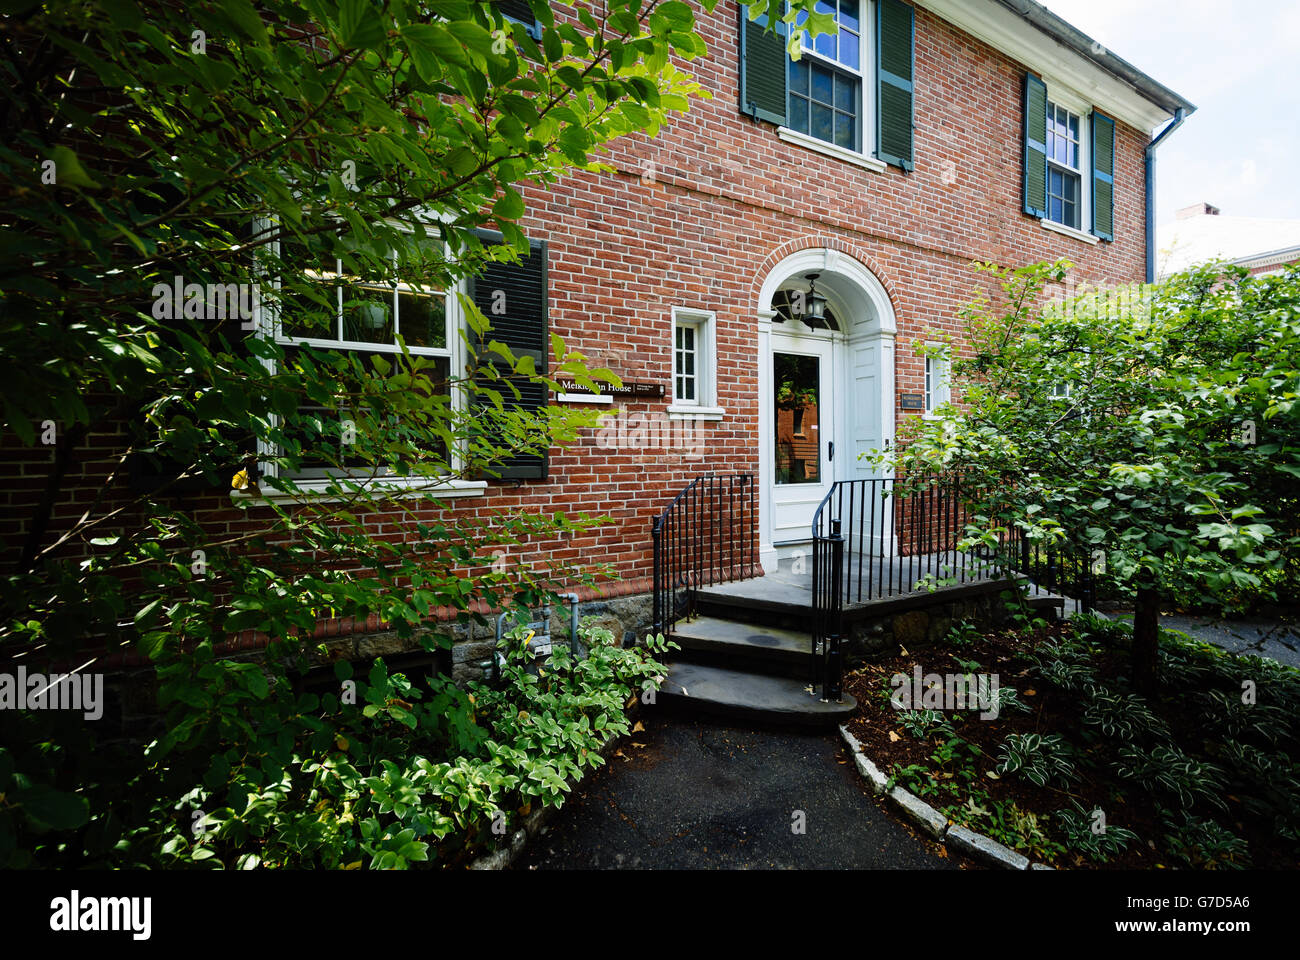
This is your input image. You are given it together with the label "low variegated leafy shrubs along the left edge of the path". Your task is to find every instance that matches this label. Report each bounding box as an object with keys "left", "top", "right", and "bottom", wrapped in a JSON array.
[{"left": 0, "top": 616, "right": 671, "bottom": 869}]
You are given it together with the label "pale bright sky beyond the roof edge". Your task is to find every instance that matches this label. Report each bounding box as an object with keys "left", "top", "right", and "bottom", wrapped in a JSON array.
[{"left": 1040, "top": 0, "right": 1300, "bottom": 224}]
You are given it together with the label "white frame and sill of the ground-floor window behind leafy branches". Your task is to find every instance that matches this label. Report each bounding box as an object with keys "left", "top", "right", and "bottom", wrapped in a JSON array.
[{"left": 231, "top": 220, "right": 488, "bottom": 502}]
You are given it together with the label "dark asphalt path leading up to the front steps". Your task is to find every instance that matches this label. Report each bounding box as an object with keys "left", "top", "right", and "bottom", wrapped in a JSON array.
[{"left": 516, "top": 712, "right": 957, "bottom": 870}]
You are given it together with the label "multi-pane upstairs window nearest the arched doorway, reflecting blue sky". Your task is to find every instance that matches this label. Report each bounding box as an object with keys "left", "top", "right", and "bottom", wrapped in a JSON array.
[{"left": 788, "top": 0, "right": 865, "bottom": 152}]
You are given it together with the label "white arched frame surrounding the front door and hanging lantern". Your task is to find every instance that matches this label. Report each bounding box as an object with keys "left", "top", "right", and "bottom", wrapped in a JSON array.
[{"left": 755, "top": 247, "right": 897, "bottom": 572}]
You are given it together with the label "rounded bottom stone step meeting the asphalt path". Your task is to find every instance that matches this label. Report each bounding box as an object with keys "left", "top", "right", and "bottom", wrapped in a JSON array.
[{"left": 659, "top": 661, "right": 858, "bottom": 727}]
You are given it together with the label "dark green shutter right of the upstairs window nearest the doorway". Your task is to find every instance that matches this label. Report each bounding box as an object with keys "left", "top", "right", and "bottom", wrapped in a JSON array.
[{"left": 876, "top": 0, "right": 917, "bottom": 170}]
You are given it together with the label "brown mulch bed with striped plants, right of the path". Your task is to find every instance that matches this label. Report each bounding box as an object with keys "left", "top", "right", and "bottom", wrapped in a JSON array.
[{"left": 845, "top": 624, "right": 1297, "bottom": 870}]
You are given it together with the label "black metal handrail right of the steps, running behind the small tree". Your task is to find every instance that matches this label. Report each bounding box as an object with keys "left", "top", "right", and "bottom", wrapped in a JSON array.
[{"left": 811, "top": 475, "right": 1096, "bottom": 700}]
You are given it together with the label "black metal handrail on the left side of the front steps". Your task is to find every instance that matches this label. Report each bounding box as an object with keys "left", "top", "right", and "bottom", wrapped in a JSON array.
[{"left": 651, "top": 473, "right": 761, "bottom": 636}]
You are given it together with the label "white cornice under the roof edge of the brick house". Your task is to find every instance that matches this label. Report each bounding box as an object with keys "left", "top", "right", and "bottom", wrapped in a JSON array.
[{"left": 913, "top": 0, "right": 1173, "bottom": 134}]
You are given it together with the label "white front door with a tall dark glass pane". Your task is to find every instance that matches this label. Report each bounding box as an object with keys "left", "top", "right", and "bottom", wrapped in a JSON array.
[{"left": 762, "top": 330, "right": 848, "bottom": 546}]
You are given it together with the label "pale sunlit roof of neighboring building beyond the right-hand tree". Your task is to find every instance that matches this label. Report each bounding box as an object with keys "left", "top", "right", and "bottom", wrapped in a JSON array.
[{"left": 1156, "top": 203, "right": 1300, "bottom": 277}]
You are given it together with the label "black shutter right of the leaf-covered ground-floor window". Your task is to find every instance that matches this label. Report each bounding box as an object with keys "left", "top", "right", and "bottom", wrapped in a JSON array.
[{"left": 469, "top": 232, "right": 550, "bottom": 480}]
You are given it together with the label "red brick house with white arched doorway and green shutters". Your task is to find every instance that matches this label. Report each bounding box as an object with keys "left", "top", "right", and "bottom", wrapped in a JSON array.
[{"left": 9, "top": 0, "right": 1195, "bottom": 702}]
